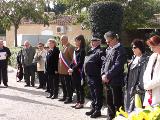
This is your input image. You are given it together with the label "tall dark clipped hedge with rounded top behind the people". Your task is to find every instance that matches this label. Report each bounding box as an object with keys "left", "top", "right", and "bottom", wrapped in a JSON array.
[{"left": 89, "top": 2, "right": 123, "bottom": 40}]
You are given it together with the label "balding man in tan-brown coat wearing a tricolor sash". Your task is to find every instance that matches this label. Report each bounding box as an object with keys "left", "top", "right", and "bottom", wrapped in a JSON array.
[{"left": 58, "top": 35, "right": 74, "bottom": 104}]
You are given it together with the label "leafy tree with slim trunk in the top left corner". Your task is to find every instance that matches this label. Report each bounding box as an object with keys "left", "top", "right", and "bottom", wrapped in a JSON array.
[{"left": 0, "top": 0, "right": 48, "bottom": 46}]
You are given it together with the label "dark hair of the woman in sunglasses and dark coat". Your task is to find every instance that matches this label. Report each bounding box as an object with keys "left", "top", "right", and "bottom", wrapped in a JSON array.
[{"left": 131, "top": 39, "right": 146, "bottom": 53}]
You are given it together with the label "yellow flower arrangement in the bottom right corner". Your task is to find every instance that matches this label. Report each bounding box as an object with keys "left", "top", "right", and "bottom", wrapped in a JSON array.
[{"left": 114, "top": 95, "right": 160, "bottom": 120}]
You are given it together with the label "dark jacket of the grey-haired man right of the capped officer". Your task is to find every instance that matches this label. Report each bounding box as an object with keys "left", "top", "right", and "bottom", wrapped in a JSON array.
[{"left": 101, "top": 45, "right": 127, "bottom": 85}]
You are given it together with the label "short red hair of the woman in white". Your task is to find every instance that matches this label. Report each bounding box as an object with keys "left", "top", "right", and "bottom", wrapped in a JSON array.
[{"left": 147, "top": 35, "right": 160, "bottom": 46}]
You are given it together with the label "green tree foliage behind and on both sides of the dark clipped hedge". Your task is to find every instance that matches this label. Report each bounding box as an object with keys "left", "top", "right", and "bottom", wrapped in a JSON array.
[{"left": 57, "top": 0, "right": 160, "bottom": 30}]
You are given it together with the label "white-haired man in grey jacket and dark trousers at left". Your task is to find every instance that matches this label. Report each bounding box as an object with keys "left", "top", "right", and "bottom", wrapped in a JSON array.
[{"left": 22, "top": 41, "right": 36, "bottom": 87}]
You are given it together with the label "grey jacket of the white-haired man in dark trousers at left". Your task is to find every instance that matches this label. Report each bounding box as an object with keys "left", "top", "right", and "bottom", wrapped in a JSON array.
[{"left": 22, "top": 46, "right": 36, "bottom": 66}]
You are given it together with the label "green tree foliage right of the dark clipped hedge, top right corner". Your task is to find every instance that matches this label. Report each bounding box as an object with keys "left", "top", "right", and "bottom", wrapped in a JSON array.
[{"left": 123, "top": 0, "right": 160, "bottom": 30}]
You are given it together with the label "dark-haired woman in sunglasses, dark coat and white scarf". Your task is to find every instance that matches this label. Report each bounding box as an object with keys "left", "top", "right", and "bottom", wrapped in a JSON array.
[{"left": 124, "top": 39, "right": 149, "bottom": 113}]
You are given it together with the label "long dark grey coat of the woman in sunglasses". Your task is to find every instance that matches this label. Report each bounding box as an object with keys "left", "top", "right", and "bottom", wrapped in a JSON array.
[{"left": 124, "top": 54, "right": 149, "bottom": 112}]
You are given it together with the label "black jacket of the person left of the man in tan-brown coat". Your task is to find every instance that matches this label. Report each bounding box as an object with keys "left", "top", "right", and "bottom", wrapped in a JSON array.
[{"left": 45, "top": 47, "right": 59, "bottom": 74}]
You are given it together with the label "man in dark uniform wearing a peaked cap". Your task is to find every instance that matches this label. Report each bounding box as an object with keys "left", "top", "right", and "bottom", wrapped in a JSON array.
[{"left": 84, "top": 37, "right": 103, "bottom": 118}]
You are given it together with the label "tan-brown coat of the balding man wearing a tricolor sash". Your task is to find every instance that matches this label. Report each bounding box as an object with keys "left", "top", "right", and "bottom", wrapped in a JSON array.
[{"left": 58, "top": 43, "right": 74, "bottom": 75}]
